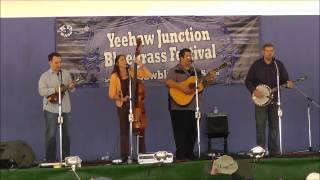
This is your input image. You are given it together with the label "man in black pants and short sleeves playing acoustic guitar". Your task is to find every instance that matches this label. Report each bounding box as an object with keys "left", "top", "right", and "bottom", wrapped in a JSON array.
[{"left": 166, "top": 48, "right": 215, "bottom": 161}]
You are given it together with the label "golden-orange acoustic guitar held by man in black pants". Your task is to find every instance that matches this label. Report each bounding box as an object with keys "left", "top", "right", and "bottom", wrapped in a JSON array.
[{"left": 169, "top": 62, "right": 227, "bottom": 106}]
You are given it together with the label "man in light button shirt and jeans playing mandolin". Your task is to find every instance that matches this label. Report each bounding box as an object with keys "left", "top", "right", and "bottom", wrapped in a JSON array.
[{"left": 39, "top": 52, "right": 75, "bottom": 162}]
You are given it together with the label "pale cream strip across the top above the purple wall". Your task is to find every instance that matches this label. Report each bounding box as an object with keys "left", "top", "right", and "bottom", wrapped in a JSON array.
[{"left": 1, "top": 0, "right": 319, "bottom": 17}]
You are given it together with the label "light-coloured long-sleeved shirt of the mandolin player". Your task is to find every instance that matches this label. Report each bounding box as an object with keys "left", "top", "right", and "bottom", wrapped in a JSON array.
[{"left": 39, "top": 68, "right": 75, "bottom": 113}]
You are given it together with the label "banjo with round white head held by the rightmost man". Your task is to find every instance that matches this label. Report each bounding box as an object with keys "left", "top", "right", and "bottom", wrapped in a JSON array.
[{"left": 252, "top": 76, "right": 307, "bottom": 107}]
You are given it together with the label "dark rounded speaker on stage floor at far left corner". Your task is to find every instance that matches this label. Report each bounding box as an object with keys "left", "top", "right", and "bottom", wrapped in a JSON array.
[{"left": 0, "top": 140, "right": 35, "bottom": 168}]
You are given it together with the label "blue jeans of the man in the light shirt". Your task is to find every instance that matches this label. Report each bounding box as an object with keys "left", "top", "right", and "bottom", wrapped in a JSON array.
[{"left": 44, "top": 111, "right": 70, "bottom": 162}]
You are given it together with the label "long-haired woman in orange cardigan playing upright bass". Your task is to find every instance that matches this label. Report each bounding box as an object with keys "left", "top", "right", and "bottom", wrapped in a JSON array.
[{"left": 109, "top": 55, "right": 151, "bottom": 162}]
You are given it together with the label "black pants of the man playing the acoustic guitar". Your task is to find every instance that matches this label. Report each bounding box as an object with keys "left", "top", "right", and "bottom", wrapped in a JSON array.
[{"left": 170, "top": 110, "right": 197, "bottom": 159}]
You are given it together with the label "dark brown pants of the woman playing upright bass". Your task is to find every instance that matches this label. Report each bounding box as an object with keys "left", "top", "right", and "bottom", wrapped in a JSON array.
[{"left": 117, "top": 103, "right": 146, "bottom": 160}]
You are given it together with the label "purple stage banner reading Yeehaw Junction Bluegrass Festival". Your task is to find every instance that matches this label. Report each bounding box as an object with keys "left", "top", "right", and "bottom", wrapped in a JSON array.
[{"left": 56, "top": 16, "right": 260, "bottom": 87}]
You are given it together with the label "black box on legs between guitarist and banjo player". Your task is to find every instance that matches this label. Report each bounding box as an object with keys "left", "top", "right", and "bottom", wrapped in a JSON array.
[{"left": 207, "top": 113, "right": 229, "bottom": 137}]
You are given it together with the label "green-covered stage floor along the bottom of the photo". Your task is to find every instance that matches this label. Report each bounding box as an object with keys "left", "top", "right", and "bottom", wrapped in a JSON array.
[{"left": 0, "top": 155, "right": 320, "bottom": 180}]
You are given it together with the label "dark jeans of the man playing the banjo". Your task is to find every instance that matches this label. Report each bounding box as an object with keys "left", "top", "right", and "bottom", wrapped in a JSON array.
[{"left": 255, "top": 104, "right": 279, "bottom": 154}]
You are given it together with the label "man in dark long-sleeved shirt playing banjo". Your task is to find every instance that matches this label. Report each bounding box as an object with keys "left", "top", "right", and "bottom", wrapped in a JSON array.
[{"left": 245, "top": 43, "right": 293, "bottom": 156}]
